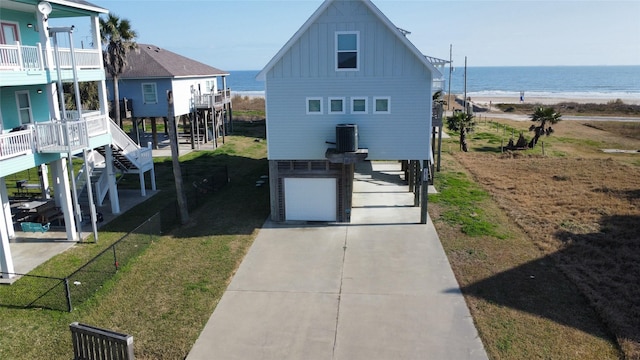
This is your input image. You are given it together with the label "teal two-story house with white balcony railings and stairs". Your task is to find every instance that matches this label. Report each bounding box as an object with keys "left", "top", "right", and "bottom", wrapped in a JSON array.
[{"left": 0, "top": 0, "right": 155, "bottom": 279}]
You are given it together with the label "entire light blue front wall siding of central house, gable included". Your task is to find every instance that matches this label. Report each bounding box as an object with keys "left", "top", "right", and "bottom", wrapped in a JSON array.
[{"left": 266, "top": 1, "right": 432, "bottom": 160}]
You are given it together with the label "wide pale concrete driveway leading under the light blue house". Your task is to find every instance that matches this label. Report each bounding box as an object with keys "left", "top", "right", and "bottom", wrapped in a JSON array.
[{"left": 187, "top": 163, "right": 487, "bottom": 360}]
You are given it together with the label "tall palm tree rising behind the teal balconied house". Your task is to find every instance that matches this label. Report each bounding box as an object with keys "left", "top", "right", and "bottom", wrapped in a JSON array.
[{"left": 100, "top": 14, "right": 138, "bottom": 127}]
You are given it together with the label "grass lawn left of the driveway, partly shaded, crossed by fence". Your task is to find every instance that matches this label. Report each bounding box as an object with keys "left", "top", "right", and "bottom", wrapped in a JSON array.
[{"left": 0, "top": 122, "right": 269, "bottom": 359}]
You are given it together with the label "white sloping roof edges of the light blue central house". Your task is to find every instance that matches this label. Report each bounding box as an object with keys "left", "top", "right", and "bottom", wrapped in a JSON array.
[{"left": 256, "top": 0, "right": 442, "bottom": 80}]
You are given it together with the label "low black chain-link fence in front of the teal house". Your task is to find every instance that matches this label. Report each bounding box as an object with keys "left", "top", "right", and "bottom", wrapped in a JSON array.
[{"left": 0, "top": 213, "right": 161, "bottom": 311}]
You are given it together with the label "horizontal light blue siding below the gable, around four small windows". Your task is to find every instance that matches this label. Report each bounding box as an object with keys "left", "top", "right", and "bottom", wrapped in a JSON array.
[{"left": 267, "top": 73, "right": 431, "bottom": 160}]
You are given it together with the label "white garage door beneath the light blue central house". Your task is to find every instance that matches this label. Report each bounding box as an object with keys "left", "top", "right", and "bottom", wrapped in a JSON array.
[{"left": 284, "top": 178, "right": 337, "bottom": 221}]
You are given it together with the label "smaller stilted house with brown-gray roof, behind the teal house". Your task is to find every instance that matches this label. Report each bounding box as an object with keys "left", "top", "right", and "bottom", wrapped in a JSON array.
[{"left": 107, "top": 44, "right": 231, "bottom": 148}]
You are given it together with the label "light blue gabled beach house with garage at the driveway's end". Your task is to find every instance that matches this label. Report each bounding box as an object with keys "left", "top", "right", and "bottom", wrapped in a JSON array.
[{"left": 258, "top": 0, "right": 442, "bottom": 222}]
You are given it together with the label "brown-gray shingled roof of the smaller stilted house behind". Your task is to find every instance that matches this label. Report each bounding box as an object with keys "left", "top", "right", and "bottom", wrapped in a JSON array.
[{"left": 120, "top": 44, "right": 229, "bottom": 79}]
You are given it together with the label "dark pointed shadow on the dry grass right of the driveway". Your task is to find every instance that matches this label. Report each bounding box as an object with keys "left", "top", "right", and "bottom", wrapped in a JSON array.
[{"left": 448, "top": 212, "right": 640, "bottom": 359}]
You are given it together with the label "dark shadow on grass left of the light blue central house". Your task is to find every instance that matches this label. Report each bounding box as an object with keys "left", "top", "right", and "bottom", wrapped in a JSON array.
[{"left": 101, "top": 152, "right": 269, "bottom": 238}]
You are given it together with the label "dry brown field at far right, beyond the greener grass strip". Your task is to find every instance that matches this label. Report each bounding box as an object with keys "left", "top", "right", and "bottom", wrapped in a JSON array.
[{"left": 455, "top": 153, "right": 640, "bottom": 359}]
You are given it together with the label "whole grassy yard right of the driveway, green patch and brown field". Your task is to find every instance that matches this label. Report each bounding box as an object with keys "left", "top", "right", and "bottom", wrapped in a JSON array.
[{"left": 436, "top": 116, "right": 640, "bottom": 359}]
